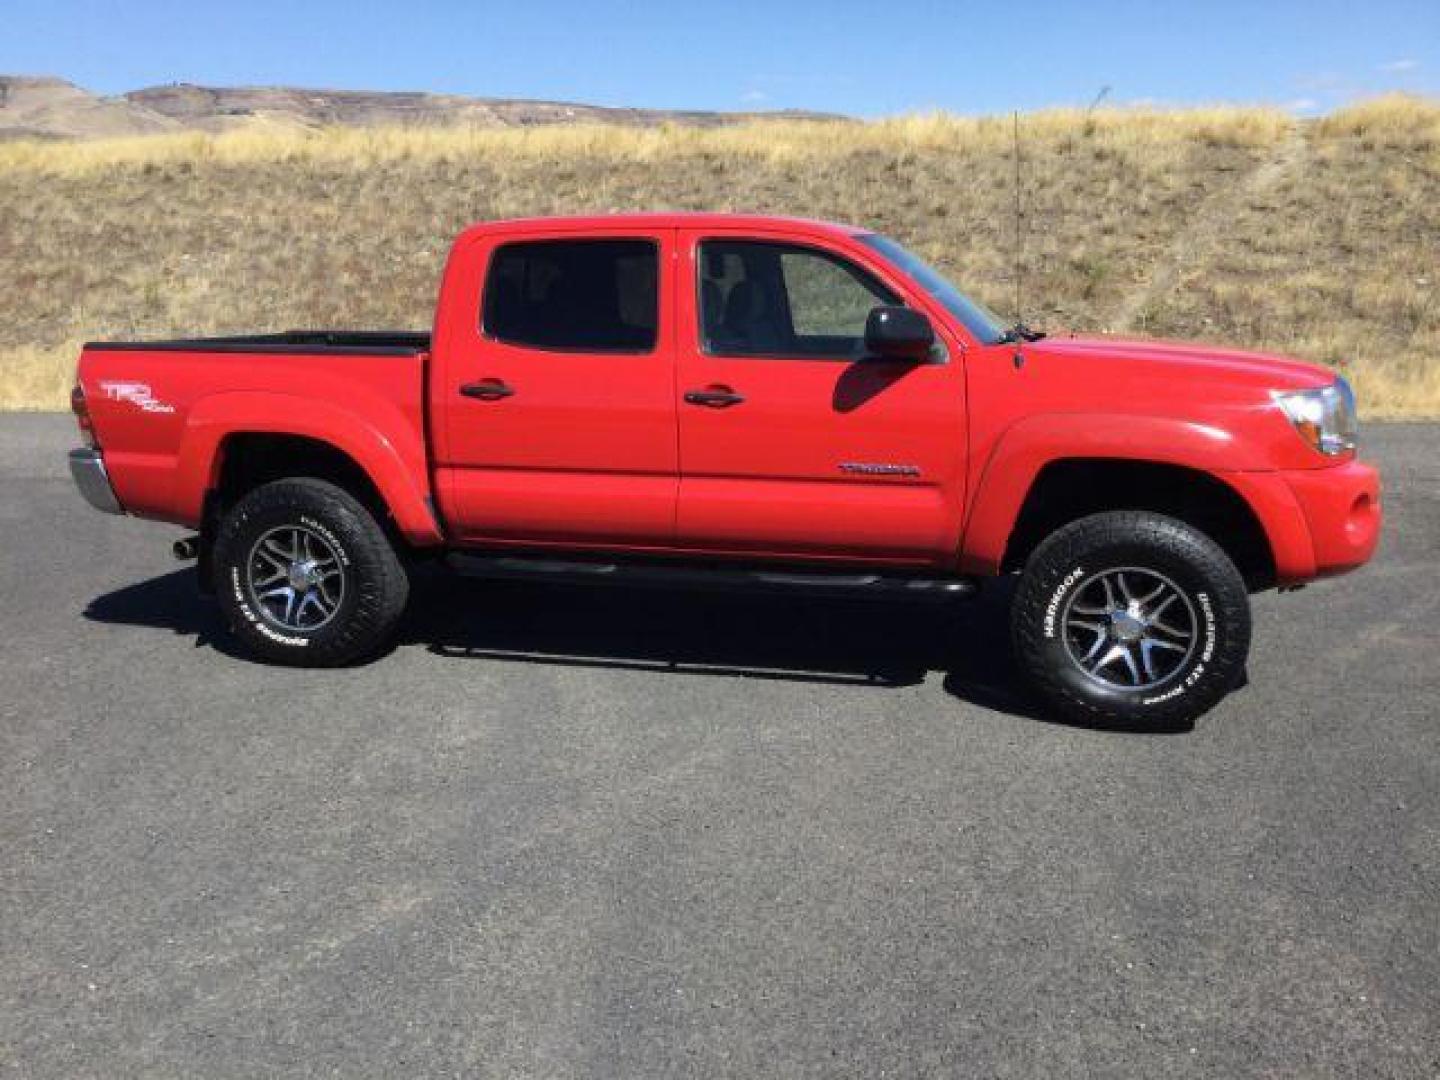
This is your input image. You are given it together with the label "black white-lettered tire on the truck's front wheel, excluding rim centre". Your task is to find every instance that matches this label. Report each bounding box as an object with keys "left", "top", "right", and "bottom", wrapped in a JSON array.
[{"left": 1011, "top": 511, "right": 1250, "bottom": 730}]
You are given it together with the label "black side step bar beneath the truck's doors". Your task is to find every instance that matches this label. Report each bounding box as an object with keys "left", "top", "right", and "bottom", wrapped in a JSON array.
[{"left": 445, "top": 552, "right": 979, "bottom": 599}]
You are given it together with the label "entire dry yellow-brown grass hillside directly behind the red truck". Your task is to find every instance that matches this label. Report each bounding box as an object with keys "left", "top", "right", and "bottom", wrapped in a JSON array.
[{"left": 0, "top": 98, "right": 1440, "bottom": 416}]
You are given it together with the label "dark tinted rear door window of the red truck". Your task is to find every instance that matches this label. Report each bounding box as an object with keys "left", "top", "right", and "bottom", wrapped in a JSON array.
[{"left": 484, "top": 240, "right": 658, "bottom": 353}]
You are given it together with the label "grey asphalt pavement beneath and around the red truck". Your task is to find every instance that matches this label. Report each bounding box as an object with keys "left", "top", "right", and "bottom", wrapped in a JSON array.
[{"left": 0, "top": 416, "right": 1440, "bottom": 1079}]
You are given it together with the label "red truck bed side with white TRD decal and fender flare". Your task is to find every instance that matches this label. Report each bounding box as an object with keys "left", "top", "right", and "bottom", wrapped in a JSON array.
[{"left": 78, "top": 330, "right": 435, "bottom": 539}]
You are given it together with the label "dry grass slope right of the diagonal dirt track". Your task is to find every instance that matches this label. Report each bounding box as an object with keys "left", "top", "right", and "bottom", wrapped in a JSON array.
[{"left": 1148, "top": 96, "right": 1440, "bottom": 416}]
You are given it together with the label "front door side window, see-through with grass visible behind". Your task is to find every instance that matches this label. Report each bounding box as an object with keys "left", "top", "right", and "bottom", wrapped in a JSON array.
[{"left": 700, "top": 240, "right": 900, "bottom": 357}]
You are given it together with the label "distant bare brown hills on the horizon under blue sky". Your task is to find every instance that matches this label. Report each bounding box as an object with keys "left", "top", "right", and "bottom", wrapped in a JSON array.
[{"left": 0, "top": 75, "right": 840, "bottom": 138}]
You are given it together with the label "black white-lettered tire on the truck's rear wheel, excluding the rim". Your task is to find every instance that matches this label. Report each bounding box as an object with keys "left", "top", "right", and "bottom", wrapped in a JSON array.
[{"left": 213, "top": 478, "right": 409, "bottom": 668}]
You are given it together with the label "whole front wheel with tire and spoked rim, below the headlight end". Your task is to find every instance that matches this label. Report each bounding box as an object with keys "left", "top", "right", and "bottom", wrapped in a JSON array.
[{"left": 1011, "top": 511, "right": 1250, "bottom": 730}]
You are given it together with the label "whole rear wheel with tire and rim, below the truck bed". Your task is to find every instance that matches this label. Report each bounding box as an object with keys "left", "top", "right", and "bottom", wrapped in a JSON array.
[{"left": 213, "top": 478, "right": 409, "bottom": 667}]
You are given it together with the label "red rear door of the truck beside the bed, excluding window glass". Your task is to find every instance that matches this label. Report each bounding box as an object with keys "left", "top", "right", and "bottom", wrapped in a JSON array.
[{"left": 432, "top": 229, "right": 678, "bottom": 546}]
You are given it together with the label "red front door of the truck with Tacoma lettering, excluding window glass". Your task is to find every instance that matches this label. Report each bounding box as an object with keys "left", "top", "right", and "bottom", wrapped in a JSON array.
[{"left": 675, "top": 230, "right": 965, "bottom": 564}]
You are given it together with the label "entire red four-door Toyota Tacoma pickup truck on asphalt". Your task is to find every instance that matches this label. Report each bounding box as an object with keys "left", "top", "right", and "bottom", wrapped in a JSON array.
[{"left": 71, "top": 213, "right": 1381, "bottom": 726}]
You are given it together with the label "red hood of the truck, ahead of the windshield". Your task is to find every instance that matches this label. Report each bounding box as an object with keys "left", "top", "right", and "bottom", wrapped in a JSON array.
[{"left": 1025, "top": 337, "right": 1335, "bottom": 390}]
